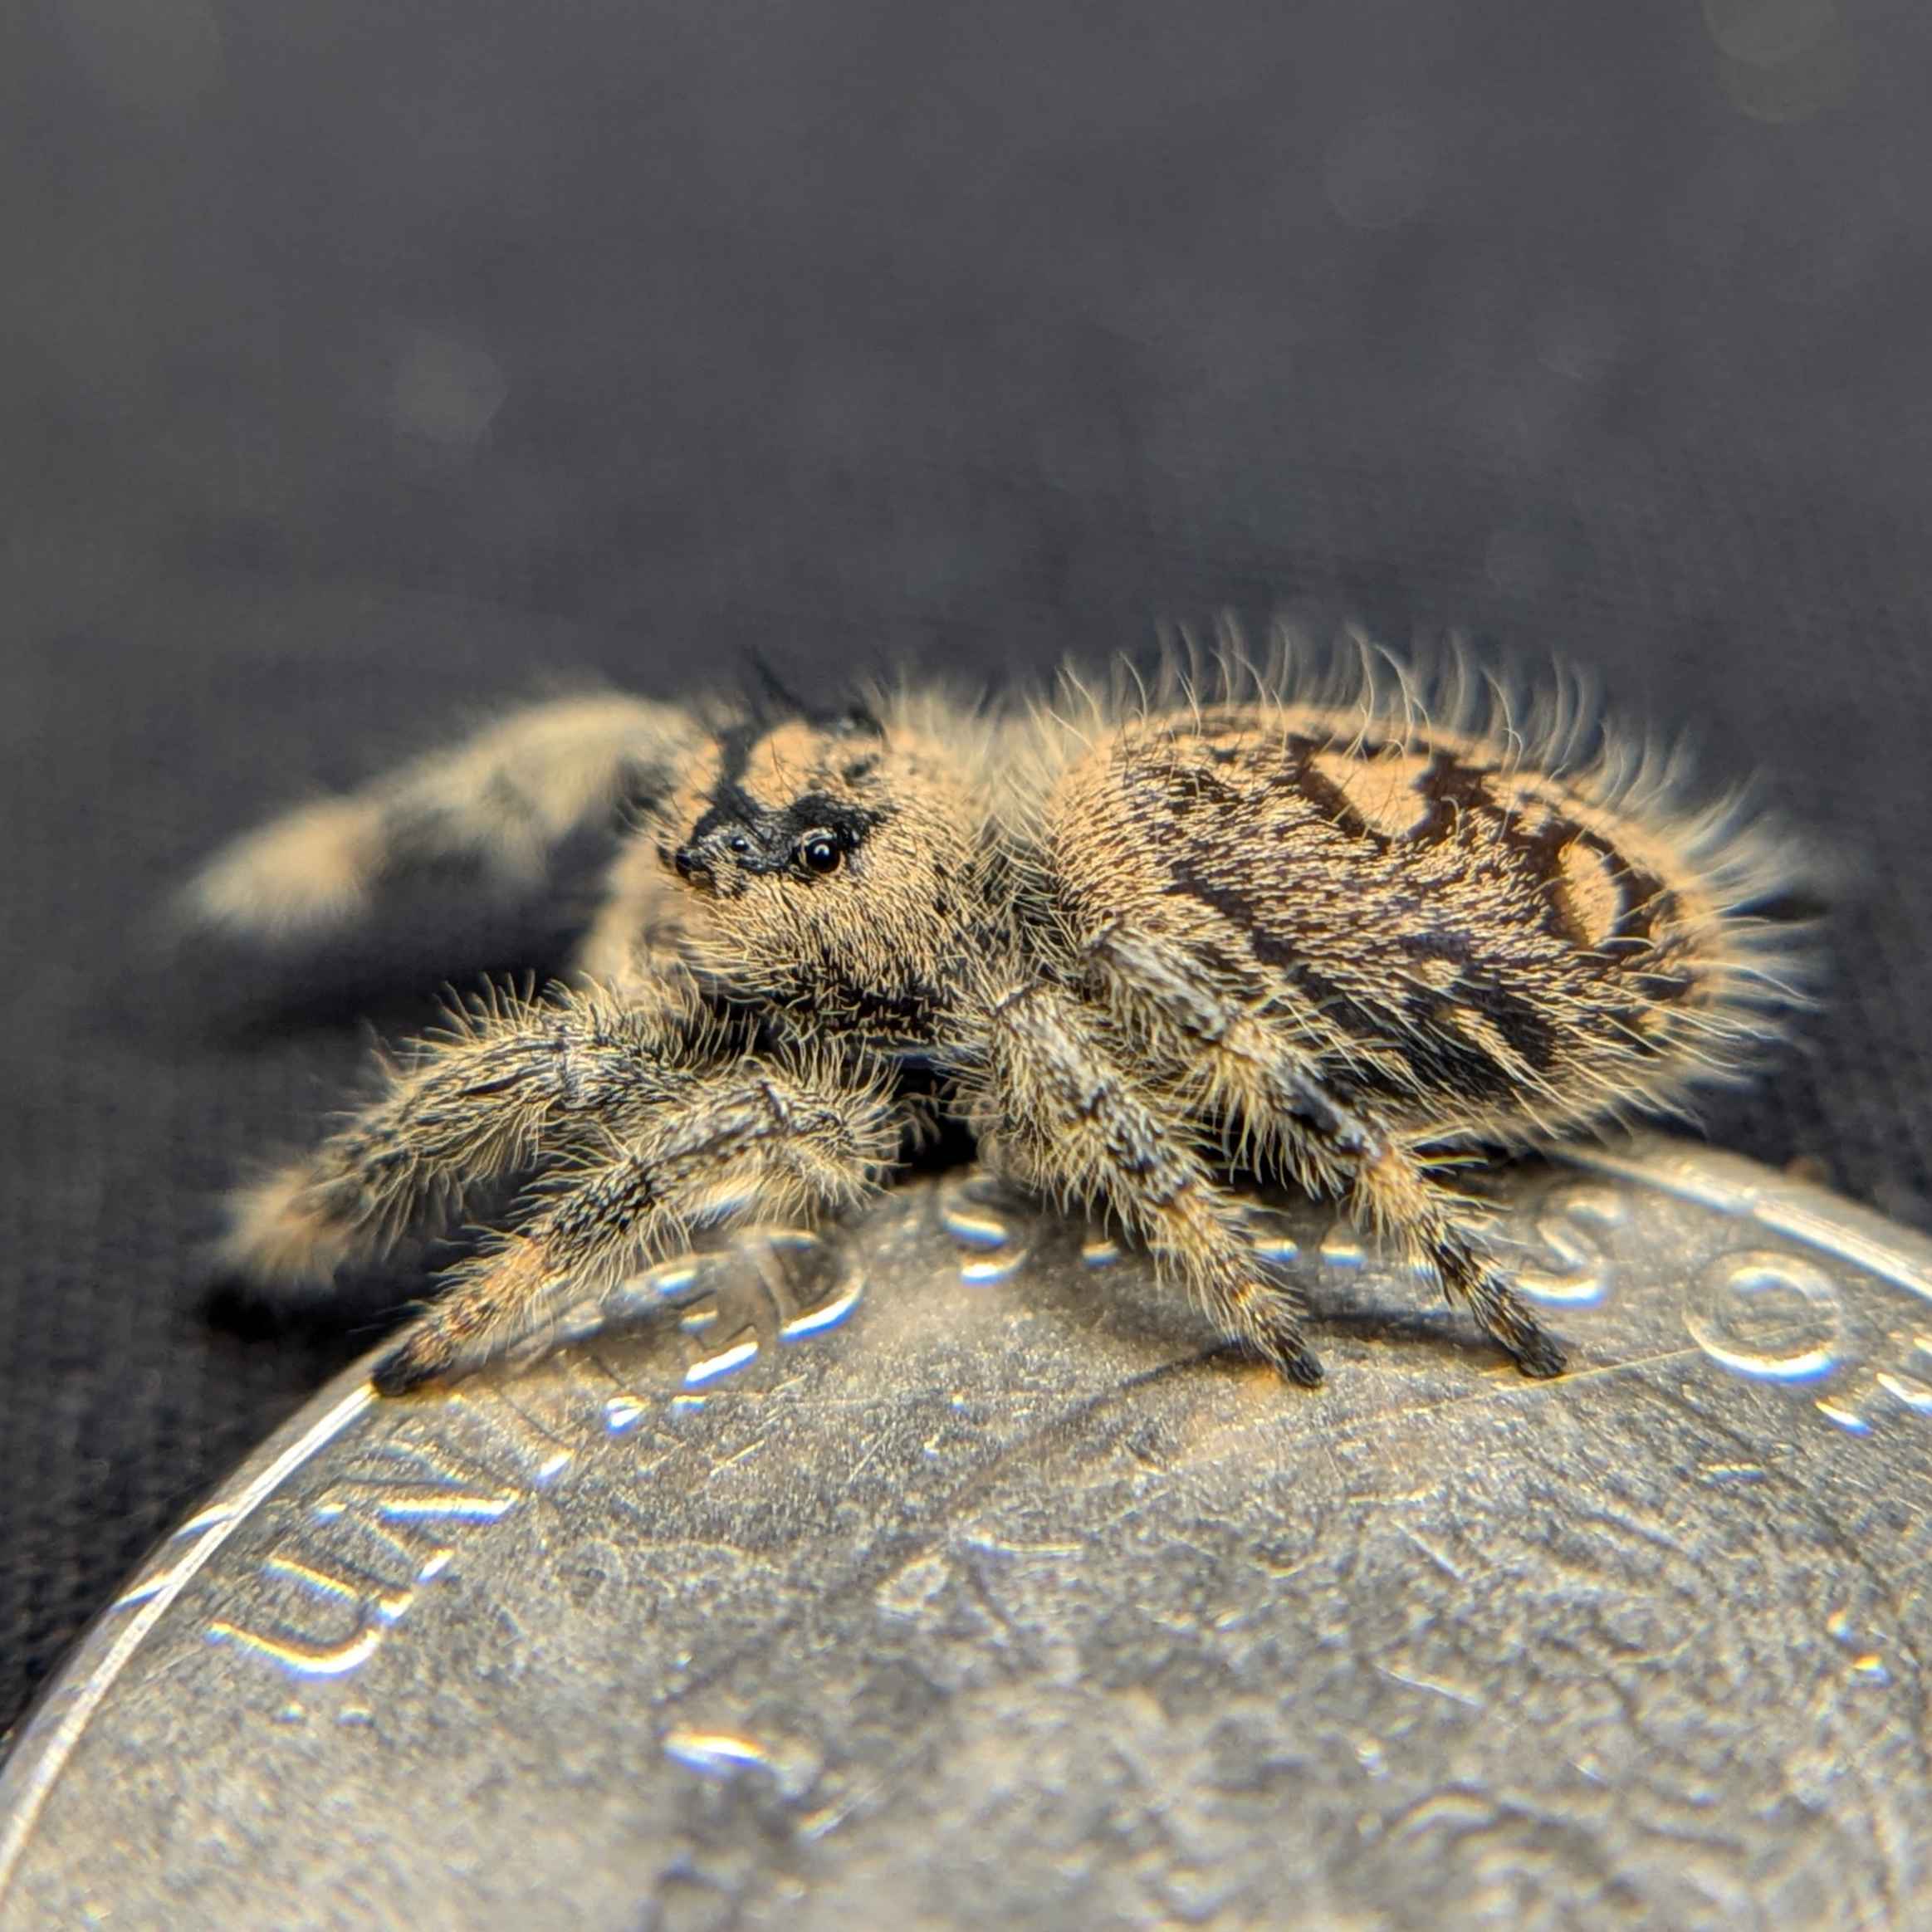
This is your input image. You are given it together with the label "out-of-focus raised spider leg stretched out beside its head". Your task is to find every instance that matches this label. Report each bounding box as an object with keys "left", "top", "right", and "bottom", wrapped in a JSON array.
[{"left": 179, "top": 692, "right": 702, "bottom": 943}]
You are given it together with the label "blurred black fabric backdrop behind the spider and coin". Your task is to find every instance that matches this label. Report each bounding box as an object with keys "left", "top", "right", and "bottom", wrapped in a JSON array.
[{"left": 0, "top": 0, "right": 1932, "bottom": 1746}]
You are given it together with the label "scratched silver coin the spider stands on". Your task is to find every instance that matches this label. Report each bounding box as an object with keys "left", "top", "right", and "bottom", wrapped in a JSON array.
[{"left": 0, "top": 1142, "right": 1932, "bottom": 1932}]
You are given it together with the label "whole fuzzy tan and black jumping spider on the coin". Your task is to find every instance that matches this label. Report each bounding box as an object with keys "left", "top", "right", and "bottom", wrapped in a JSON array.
[{"left": 193, "top": 653, "right": 1793, "bottom": 1395}]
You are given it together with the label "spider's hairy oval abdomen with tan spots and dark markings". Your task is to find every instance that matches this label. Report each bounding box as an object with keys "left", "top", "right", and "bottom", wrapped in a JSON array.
[{"left": 1045, "top": 703, "right": 1793, "bottom": 1134}]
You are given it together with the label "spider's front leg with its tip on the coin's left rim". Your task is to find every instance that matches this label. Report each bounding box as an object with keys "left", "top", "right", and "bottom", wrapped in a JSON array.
[{"left": 374, "top": 1053, "right": 900, "bottom": 1395}]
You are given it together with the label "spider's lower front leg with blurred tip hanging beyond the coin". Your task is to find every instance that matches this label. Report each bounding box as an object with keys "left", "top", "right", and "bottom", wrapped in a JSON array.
[{"left": 224, "top": 987, "right": 709, "bottom": 1283}]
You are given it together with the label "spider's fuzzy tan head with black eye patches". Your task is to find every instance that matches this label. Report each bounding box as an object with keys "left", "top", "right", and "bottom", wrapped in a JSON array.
[{"left": 657, "top": 709, "right": 986, "bottom": 1045}]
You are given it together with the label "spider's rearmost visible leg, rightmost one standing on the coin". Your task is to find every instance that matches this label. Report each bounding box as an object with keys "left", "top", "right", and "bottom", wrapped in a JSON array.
[{"left": 1088, "top": 929, "right": 1563, "bottom": 1376}]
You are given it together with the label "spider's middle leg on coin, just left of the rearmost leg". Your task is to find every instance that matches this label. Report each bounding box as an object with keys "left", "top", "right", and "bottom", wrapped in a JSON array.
[{"left": 976, "top": 983, "right": 1322, "bottom": 1387}]
